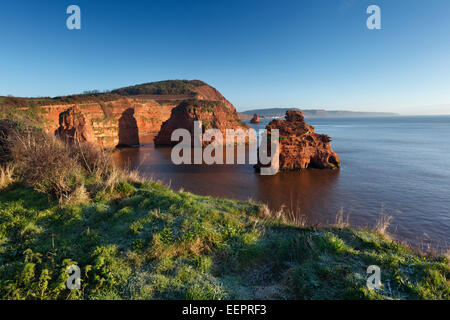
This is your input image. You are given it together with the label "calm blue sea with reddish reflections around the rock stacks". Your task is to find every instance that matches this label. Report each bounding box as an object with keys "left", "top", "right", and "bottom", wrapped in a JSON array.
[{"left": 114, "top": 116, "right": 450, "bottom": 251}]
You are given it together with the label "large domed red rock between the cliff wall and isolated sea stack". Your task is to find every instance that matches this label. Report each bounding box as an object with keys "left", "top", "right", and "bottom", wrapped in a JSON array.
[{"left": 154, "top": 100, "right": 253, "bottom": 146}]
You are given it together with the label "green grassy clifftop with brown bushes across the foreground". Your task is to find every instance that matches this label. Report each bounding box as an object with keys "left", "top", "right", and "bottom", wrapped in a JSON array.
[{"left": 0, "top": 114, "right": 450, "bottom": 299}]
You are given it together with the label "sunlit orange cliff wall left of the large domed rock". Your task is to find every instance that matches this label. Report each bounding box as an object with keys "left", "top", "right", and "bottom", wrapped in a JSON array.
[{"left": 41, "top": 98, "right": 175, "bottom": 148}]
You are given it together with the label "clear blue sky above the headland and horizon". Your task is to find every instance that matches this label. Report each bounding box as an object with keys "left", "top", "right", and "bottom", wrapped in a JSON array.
[{"left": 0, "top": 0, "right": 450, "bottom": 114}]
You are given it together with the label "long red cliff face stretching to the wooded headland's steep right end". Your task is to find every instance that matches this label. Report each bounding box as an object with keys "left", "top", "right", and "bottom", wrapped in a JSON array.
[{"left": 35, "top": 81, "right": 237, "bottom": 148}]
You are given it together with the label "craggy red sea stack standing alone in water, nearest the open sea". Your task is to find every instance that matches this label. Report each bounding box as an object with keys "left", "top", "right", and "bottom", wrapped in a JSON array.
[{"left": 255, "top": 111, "right": 340, "bottom": 170}]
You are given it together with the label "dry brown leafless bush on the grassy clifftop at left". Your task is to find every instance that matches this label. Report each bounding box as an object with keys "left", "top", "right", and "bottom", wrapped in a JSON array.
[{"left": 0, "top": 121, "right": 140, "bottom": 203}]
